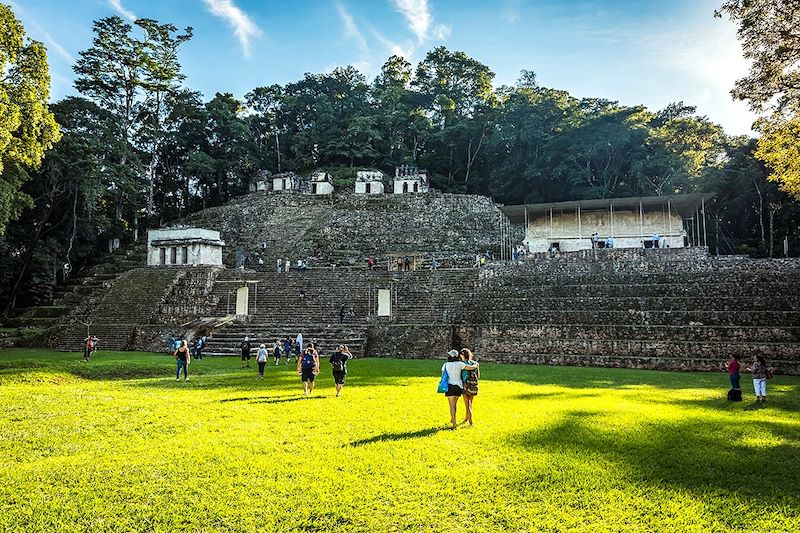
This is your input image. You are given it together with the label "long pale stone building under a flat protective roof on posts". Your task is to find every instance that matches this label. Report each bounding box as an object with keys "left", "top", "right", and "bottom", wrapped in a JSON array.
[{"left": 500, "top": 193, "right": 714, "bottom": 253}]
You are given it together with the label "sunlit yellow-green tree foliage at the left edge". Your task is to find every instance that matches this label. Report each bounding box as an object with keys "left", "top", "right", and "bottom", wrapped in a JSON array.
[{"left": 0, "top": 4, "right": 60, "bottom": 235}]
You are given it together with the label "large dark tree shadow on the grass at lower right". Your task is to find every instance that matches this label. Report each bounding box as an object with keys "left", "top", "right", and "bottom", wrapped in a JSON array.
[{"left": 507, "top": 412, "right": 800, "bottom": 501}]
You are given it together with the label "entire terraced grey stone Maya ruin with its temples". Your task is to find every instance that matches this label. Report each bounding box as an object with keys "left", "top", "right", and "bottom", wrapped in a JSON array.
[{"left": 12, "top": 168, "right": 800, "bottom": 374}]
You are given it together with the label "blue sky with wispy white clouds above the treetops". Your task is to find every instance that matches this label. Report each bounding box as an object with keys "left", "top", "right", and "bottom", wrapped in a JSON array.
[{"left": 7, "top": 0, "right": 754, "bottom": 134}]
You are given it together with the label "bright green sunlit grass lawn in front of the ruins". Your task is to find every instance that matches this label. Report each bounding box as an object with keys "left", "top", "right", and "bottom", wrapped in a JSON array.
[{"left": 0, "top": 349, "right": 800, "bottom": 532}]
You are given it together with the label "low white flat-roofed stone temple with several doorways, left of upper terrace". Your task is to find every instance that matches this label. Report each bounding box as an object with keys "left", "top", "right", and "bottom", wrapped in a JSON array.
[{"left": 147, "top": 228, "right": 225, "bottom": 266}]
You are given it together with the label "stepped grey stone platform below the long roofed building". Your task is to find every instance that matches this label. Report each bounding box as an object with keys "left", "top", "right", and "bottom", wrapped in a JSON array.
[{"left": 465, "top": 258, "right": 800, "bottom": 373}]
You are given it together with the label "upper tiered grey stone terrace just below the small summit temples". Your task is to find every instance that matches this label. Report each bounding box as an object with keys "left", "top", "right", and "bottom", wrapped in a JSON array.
[{"left": 184, "top": 192, "right": 501, "bottom": 269}]
